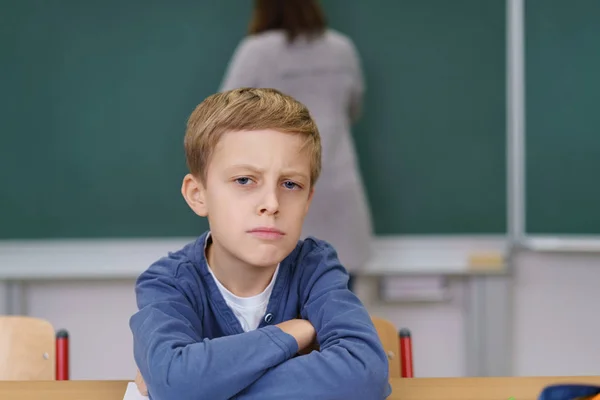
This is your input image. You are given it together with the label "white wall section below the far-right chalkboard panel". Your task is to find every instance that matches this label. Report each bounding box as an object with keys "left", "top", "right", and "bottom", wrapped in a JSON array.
[{"left": 514, "top": 253, "right": 600, "bottom": 375}]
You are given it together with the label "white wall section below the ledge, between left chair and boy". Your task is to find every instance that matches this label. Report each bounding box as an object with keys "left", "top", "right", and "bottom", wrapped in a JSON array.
[{"left": 26, "top": 280, "right": 136, "bottom": 379}]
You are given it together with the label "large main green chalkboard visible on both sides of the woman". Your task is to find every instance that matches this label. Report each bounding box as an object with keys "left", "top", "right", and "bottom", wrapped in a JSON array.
[{"left": 0, "top": 0, "right": 506, "bottom": 238}]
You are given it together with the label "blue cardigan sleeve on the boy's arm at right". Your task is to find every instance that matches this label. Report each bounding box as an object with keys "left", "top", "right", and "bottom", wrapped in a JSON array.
[{"left": 235, "top": 242, "right": 391, "bottom": 400}]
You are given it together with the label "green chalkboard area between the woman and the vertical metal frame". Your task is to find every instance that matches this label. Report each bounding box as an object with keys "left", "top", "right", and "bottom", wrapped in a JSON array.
[{"left": 325, "top": 0, "right": 506, "bottom": 234}]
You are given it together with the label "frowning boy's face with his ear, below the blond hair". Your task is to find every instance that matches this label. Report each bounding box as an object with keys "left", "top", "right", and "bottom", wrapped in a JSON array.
[{"left": 182, "top": 130, "right": 312, "bottom": 267}]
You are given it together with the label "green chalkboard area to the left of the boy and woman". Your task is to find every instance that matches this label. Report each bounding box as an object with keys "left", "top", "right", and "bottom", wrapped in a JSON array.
[{"left": 0, "top": 0, "right": 251, "bottom": 238}]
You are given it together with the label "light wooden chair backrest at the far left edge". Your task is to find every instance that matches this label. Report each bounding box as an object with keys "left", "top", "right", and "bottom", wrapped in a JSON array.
[{"left": 0, "top": 316, "right": 56, "bottom": 381}]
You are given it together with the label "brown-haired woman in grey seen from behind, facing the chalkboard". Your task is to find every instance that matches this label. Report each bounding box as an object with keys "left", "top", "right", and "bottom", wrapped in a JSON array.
[{"left": 221, "top": 0, "right": 372, "bottom": 287}]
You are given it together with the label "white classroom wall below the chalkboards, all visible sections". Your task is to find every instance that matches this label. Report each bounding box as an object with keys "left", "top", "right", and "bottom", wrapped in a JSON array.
[{"left": 17, "top": 253, "right": 600, "bottom": 379}]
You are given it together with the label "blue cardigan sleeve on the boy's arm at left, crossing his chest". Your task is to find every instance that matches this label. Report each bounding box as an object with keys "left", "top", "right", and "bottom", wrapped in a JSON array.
[{"left": 130, "top": 266, "right": 298, "bottom": 400}]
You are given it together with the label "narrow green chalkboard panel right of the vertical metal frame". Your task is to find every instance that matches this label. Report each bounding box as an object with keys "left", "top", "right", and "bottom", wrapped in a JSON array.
[{"left": 525, "top": 0, "right": 600, "bottom": 234}]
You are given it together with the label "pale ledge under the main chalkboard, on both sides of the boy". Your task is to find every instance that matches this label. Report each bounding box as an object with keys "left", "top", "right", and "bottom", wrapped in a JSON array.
[{"left": 0, "top": 236, "right": 506, "bottom": 281}]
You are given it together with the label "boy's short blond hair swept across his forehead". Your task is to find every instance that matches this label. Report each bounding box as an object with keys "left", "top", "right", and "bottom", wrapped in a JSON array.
[{"left": 184, "top": 88, "right": 321, "bottom": 186}]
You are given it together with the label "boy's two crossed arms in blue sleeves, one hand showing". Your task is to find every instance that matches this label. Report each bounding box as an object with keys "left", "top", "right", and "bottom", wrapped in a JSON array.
[{"left": 131, "top": 248, "right": 390, "bottom": 400}]
